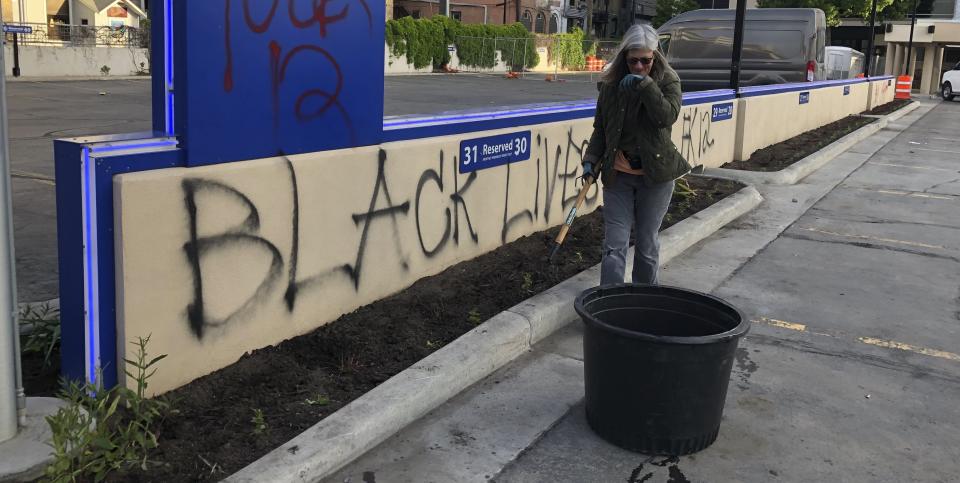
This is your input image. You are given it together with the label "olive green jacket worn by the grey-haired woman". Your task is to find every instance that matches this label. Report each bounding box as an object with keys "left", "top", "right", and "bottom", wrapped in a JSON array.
[{"left": 583, "top": 68, "right": 691, "bottom": 184}]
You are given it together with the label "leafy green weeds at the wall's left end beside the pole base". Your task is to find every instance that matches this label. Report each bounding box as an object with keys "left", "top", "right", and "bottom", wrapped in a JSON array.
[{"left": 45, "top": 336, "right": 175, "bottom": 482}]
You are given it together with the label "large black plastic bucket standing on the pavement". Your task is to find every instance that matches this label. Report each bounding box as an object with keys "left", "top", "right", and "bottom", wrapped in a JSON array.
[{"left": 574, "top": 284, "right": 750, "bottom": 455}]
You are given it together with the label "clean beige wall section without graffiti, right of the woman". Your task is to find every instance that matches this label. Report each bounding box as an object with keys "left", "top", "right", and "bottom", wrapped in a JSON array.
[{"left": 734, "top": 83, "right": 869, "bottom": 160}]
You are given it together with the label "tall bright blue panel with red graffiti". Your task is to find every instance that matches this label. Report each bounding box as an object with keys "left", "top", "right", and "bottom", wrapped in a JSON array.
[{"left": 165, "top": 0, "right": 385, "bottom": 166}]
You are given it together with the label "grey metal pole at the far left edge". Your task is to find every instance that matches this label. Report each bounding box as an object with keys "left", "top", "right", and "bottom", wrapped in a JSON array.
[{"left": 0, "top": 9, "right": 26, "bottom": 441}]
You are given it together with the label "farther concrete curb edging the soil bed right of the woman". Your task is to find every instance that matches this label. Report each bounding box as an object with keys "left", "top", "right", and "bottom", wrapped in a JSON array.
[{"left": 703, "top": 102, "right": 920, "bottom": 185}]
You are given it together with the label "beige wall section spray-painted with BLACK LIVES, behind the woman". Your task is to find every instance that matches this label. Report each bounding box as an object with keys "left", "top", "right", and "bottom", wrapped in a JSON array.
[{"left": 114, "top": 96, "right": 736, "bottom": 393}]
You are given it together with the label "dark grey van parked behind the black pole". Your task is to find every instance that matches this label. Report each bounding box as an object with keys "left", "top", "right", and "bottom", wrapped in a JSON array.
[{"left": 659, "top": 8, "right": 827, "bottom": 92}]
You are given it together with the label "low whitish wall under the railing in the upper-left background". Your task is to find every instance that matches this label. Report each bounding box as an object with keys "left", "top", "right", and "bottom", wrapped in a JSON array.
[{"left": 4, "top": 44, "right": 150, "bottom": 77}]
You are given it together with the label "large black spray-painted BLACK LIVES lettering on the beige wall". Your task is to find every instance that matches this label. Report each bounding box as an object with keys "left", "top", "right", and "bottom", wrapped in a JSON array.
[{"left": 181, "top": 130, "right": 597, "bottom": 339}]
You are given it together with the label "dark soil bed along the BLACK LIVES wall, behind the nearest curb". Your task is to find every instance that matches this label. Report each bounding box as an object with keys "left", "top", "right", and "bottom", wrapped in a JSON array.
[{"left": 25, "top": 177, "right": 742, "bottom": 482}]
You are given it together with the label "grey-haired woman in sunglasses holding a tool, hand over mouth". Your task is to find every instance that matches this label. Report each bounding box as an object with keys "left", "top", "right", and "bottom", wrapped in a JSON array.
[{"left": 583, "top": 25, "right": 690, "bottom": 285}]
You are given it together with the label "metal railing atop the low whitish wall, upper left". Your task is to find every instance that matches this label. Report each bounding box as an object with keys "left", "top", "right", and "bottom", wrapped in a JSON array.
[{"left": 5, "top": 23, "right": 150, "bottom": 48}]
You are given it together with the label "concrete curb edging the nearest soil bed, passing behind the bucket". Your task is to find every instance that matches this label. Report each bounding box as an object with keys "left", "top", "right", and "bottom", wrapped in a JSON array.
[{"left": 225, "top": 182, "right": 762, "bottom": 482}]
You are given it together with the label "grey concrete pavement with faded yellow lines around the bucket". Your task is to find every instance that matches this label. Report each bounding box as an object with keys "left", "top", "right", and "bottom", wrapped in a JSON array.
[{"left": 328, "top": 103, "right": 960, "bottom": 483}]
